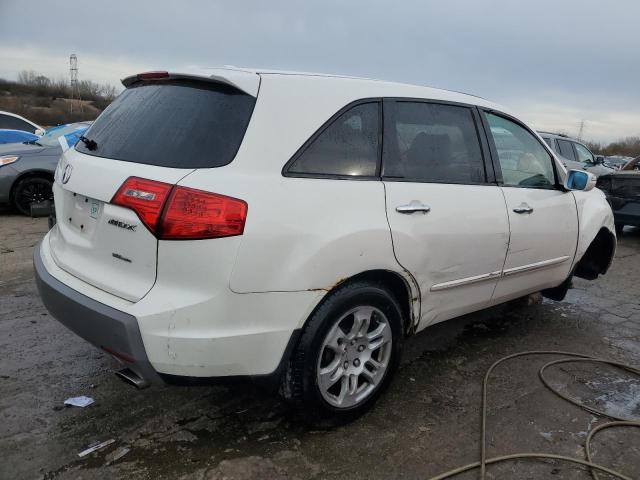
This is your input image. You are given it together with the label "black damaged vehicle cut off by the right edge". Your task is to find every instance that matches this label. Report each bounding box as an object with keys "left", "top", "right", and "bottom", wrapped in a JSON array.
[{"left": 597, "top": 168, "right": 640, "bottom": 235}]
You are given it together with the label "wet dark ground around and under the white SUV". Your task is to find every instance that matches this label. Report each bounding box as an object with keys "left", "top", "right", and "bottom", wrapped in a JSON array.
[{"left": 0, "top": 211, "right": 640, "bottom": 479}]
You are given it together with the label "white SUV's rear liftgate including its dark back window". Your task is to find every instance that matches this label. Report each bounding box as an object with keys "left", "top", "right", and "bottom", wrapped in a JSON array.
[{"left": 49, "top": 79, "right": 255, "bottom": 301}]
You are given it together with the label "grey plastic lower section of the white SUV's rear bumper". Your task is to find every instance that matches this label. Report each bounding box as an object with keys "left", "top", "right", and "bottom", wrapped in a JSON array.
[{"left": 33, "top": 244, "right": 162, "bottom": 386}]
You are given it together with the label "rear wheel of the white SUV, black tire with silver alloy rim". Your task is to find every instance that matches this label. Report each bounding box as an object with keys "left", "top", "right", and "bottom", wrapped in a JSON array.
[{"left": 282, "top": 282, "right": 404, "bottom": 427}]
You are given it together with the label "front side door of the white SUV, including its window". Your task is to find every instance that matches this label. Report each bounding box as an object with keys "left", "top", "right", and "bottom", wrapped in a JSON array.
[{"left": 483, "top": 112, "right": 578, "bottom": 303}]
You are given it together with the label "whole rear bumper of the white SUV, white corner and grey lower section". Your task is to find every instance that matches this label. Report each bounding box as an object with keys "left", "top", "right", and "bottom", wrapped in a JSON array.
[{"left": 34, "top": 238, "right": 325, "bottom": 383}]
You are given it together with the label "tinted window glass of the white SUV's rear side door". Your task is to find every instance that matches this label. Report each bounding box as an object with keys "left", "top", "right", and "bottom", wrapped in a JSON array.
[{"left": 384, "top": 102, "right": 485, "bottom": 183}]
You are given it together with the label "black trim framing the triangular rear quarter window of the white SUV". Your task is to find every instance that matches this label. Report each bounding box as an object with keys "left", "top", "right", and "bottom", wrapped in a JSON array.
[{"left": 282, "top": 97, "right": 384, "bottom": 181}]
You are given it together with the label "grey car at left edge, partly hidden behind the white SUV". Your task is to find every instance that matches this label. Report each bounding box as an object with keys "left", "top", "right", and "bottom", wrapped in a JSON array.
[{"left": 0, "top": 122, "right": 91, "bottom": 215}]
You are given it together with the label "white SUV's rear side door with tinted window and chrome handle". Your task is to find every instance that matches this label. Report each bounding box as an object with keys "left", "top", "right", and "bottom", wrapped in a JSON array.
[{"left": 383, "top": 100, "right": 509, "bottom": 328}]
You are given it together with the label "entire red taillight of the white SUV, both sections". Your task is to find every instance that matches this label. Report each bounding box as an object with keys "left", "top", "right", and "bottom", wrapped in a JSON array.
[{"left": 111, "top": 177, "right": 247, "bottom": 240}]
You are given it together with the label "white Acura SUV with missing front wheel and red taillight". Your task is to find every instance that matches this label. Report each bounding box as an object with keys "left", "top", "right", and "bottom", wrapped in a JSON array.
[{"left": 34, "top": 69, "right": 616, "bottom": 421}]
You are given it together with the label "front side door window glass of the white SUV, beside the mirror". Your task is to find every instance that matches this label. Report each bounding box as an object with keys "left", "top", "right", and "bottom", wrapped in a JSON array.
[{"left": 486, "top": 113, "right": 555, "bottom": 188}]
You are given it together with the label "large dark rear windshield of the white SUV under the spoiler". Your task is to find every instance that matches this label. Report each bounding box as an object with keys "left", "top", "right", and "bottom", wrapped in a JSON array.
[{"left": 76, "top": 81, "right": 255, "bottom": 168}]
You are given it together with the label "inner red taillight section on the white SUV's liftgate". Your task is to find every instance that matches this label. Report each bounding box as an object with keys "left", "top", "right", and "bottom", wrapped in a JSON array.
[{"left": 111, "top": 177, "right": 173, "bottom": 234}]
